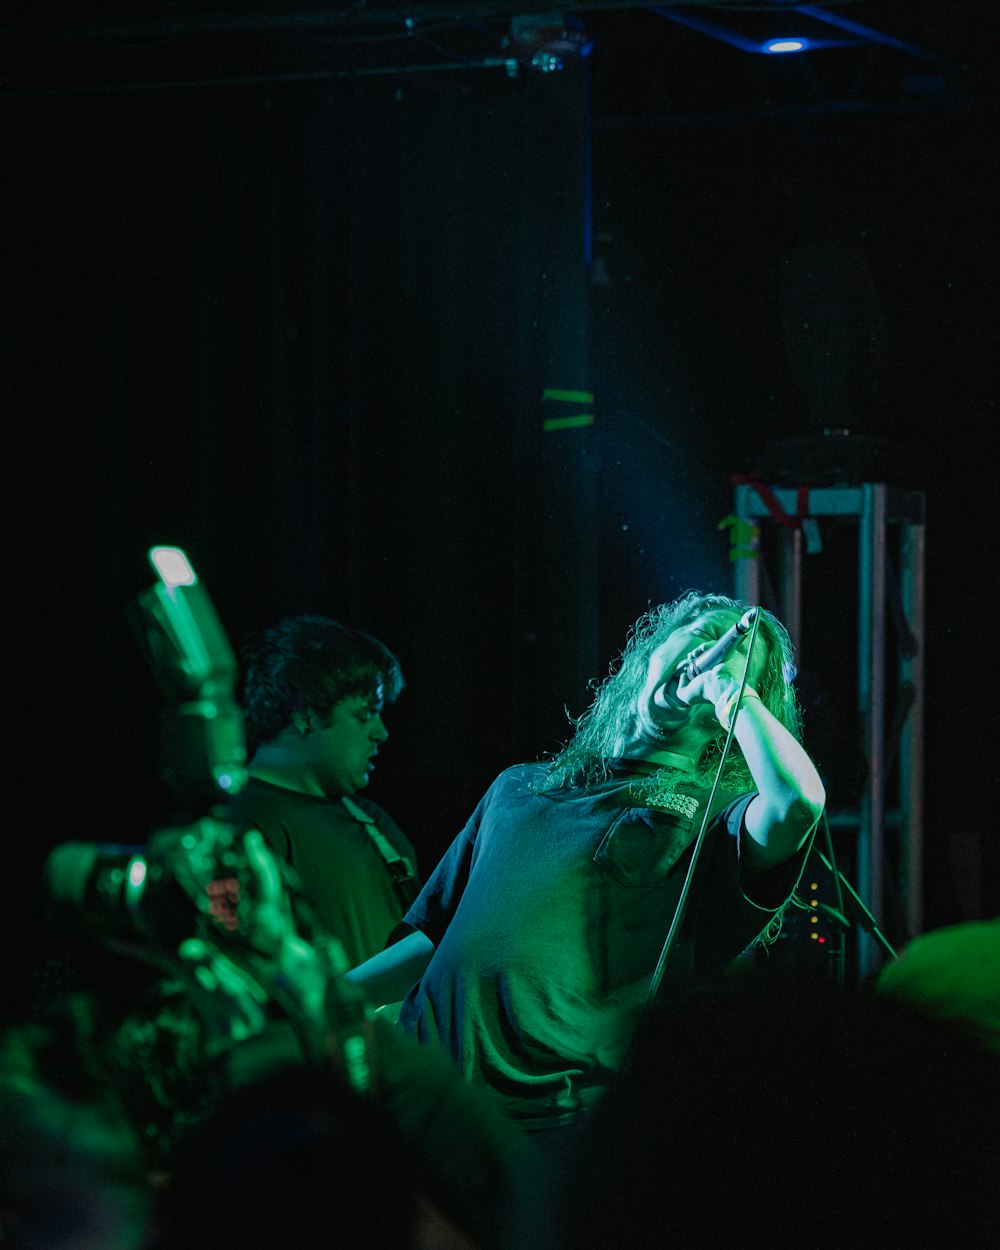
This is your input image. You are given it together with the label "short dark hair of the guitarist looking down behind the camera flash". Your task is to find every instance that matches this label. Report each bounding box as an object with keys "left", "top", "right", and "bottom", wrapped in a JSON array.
[{"left": 243, "top": 616, "right": 404, "bottom": 755}]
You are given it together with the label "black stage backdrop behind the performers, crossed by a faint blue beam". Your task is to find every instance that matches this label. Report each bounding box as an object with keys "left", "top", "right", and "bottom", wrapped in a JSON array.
[{"left": 0, "top": 3, "right": 1000, "bottom": 1005}]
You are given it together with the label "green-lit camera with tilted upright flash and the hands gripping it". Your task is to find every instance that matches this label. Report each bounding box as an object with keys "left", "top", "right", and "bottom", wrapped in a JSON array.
[{"left": 43, "top": 548, "right": 373, "bottom": 1160}]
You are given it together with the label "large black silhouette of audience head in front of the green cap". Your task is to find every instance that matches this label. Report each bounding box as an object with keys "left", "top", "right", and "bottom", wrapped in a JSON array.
[{"left": 535, "top": 978, "right": 1000, "bottom": 1250}]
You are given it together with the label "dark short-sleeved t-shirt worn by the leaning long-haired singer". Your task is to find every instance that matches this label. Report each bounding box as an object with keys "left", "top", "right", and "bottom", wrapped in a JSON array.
[{"left": 400, "top": 764, "right": 808, "bottom": 1125}]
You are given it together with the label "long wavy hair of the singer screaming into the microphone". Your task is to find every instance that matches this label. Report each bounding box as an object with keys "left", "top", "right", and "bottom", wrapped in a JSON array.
[{"left": 540, "top": 590, "right": 801, "bottom": 790}]
